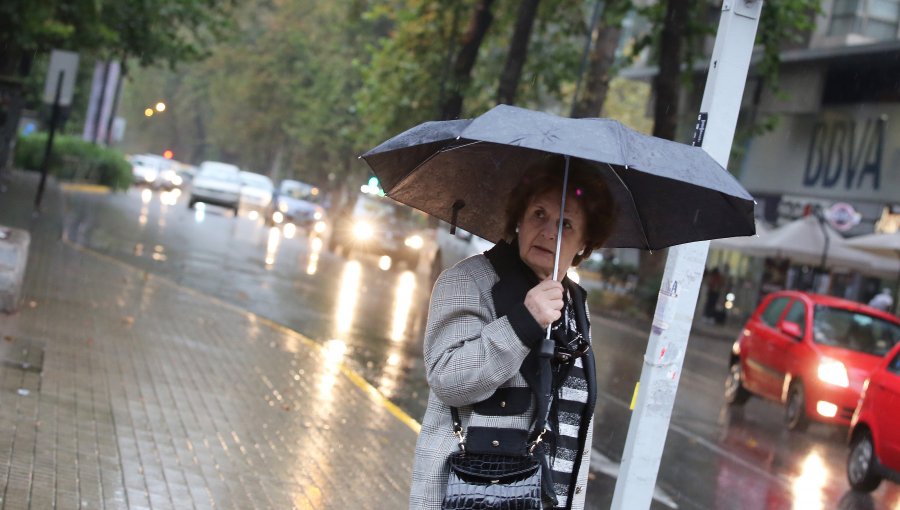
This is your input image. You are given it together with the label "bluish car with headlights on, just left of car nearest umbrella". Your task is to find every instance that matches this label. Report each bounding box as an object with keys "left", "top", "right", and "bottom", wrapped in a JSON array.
[{"left": 266, "top": 179, "right": 326, "bottom": 234}]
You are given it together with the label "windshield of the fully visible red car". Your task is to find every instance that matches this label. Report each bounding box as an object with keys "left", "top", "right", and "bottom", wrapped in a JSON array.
[{"left": 813, "top": 305, "right": 900, "bottom": 356}]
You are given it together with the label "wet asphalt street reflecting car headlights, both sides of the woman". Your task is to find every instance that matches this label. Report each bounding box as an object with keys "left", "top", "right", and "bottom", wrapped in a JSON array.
[{"left": 64, "top": 189, "right": 900, "bottom": 510}]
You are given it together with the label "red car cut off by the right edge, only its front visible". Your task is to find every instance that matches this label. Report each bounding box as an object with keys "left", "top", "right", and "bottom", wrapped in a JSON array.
[{"left": 847, "top": 344, "right": 900, "bottom": 492}]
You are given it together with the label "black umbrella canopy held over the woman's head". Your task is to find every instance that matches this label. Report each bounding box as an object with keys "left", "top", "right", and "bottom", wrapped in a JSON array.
[{"left": 362, "top": 105, "right": 755, "bottom": 250}]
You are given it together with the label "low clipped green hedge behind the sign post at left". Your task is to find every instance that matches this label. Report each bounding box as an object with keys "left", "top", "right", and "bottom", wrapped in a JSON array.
[{"left": 15, "top": 133, "right": 131, "bottom": 190}]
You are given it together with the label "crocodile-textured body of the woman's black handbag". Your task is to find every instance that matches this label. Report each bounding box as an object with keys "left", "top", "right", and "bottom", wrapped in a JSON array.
[{"left": 441, "top": 451, "right": 541, "bottom": 510}]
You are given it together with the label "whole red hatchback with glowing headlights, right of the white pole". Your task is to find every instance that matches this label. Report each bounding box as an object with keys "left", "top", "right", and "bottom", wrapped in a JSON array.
[{"left": 725, "top": 291, "right": 900, "bottom": 430}]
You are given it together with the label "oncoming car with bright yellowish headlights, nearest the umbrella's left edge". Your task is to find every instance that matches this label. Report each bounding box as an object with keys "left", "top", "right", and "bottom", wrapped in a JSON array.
[{"left": 329, "top": 193, "right": 434, "bottom": 270}]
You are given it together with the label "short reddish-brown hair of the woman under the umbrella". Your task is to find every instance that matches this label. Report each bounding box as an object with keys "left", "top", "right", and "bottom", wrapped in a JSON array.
[{"left": 504, "top": 154, "right": 617, "bottom": 266}]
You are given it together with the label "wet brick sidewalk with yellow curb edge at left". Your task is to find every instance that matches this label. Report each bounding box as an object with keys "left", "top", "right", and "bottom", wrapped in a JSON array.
[{"left": 0, "top": 174, "right": 416, "bottom": 510}]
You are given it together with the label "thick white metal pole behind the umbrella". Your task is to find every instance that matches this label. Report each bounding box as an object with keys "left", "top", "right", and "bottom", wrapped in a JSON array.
[{"left": 611, "top": 0, "right": 763, "bottom": 510}]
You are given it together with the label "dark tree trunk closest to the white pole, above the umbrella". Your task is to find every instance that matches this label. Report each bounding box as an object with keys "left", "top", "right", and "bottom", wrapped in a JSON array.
[{"left": 653, "top": 0, "right": 692, "bottom": 140}]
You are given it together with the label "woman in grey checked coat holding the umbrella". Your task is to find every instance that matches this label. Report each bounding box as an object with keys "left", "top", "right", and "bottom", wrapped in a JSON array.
[{"left": 410, "top": 156, "right": 615, "bottom": 509}]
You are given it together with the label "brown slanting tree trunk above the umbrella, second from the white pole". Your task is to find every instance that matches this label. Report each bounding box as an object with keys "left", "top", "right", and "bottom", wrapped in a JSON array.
[{"left": 572, "top": 18, "right": 622, "bottom": 118}]
